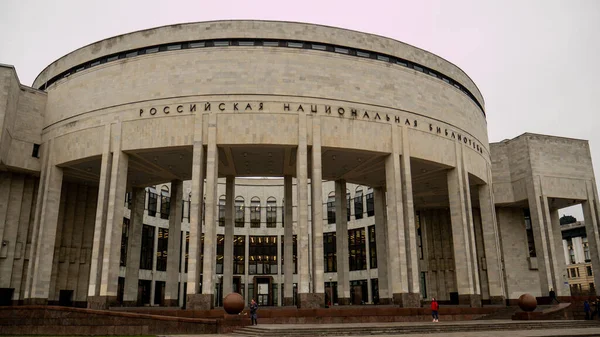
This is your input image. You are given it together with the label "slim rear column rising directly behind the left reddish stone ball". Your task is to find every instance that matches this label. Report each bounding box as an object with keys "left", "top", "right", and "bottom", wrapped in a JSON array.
[{"left": 221, "top": 176, "right": 235, "bottom": 298}]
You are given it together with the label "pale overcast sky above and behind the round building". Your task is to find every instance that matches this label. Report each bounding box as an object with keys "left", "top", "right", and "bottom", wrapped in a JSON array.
[{"left": 0, "top": 0, "right": 600, "bottom": 220}]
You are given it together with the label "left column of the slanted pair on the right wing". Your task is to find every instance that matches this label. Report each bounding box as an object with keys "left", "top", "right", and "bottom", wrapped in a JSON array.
[{"left": 527, "top": 176, "right": 556, "bottom": 296}]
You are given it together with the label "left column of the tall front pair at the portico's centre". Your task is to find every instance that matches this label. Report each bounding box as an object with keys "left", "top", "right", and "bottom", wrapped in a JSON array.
[{"left": 296, "top": 113, "right": 320, "bottom": 308}]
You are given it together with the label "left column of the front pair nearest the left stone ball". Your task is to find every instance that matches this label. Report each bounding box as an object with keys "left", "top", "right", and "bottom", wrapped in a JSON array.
[{"left": 186, "top": 109, "right": 204, "bottom": 309}]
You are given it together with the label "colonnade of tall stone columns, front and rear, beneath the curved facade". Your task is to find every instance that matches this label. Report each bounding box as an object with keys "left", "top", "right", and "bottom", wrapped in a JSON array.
[{"left": 19, "top": 113, "right": 506, "bottom": 309}]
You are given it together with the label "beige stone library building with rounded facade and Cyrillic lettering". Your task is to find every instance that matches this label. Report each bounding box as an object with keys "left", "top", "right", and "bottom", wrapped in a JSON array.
[{"left": 0, "top": 21, "right": 598, "bottom": 308}]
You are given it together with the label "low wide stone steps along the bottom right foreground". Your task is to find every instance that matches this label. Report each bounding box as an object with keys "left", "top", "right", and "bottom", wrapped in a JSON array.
[{"left": 231, "top": 321, "right": 600, "bottom": 337}]
